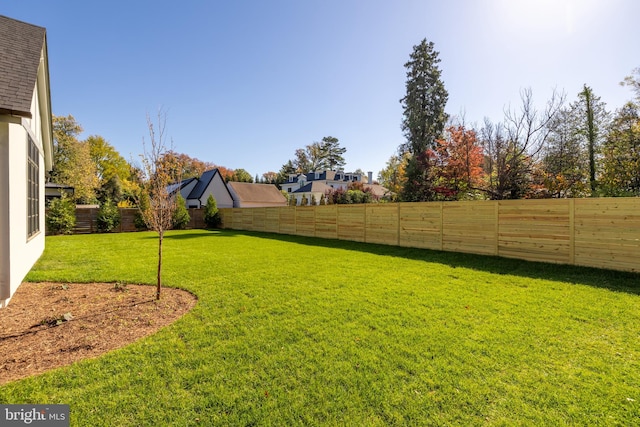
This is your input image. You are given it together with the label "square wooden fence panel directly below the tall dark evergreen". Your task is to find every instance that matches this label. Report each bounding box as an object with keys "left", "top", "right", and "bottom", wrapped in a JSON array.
[{"left": 399, "top": 202, "right": 442, "bottom": 250}]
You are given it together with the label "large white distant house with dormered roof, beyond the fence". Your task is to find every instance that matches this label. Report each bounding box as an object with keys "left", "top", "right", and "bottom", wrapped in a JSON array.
[{"left": 281, "top": 170, "right": 389, "bottom": 205}]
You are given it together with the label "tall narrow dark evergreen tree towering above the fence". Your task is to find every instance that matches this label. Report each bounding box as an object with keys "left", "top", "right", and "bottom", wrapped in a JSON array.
[{"left": 400, "top": 39, "right": 449, "bottom": 201}]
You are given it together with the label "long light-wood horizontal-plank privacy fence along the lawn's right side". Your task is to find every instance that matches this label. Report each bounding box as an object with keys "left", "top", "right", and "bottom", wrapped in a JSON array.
[{"left": 220, "top": 198, "right": 640, "bottom": 272}]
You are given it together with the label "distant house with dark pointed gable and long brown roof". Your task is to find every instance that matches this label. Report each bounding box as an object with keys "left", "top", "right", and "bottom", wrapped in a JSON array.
[{"left": 168, "top": 168, "right": 287, "bottom": 208}]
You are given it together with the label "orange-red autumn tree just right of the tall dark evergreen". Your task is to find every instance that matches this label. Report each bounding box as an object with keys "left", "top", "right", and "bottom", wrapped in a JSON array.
[{"left": 434, "top": 125, "right": 484, "bottom": 200}]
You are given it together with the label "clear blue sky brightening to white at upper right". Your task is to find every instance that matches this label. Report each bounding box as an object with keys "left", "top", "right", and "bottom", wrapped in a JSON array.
[{"left": 0, "top": 0, "right": 640, "bottom": 176}]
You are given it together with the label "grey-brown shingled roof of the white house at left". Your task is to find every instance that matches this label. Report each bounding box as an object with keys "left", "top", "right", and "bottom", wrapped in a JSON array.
[{"left": 0, "top": 15, "right": 46, "bottom": 117}]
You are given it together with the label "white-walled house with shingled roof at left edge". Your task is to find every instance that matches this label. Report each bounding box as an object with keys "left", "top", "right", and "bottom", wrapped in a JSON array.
[{"left": 0, "top": 16, "right": 53, "bottom": 307}]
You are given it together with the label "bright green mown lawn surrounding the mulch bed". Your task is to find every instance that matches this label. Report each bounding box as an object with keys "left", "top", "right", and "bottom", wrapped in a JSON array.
[{"left": 0, "top": 230, "right": 640, "bottom": 426}]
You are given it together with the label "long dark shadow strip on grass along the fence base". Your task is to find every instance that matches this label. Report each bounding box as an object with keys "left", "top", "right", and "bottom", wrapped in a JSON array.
[{"left": 225, "top": 230, "right": 640, "bottom": 295}]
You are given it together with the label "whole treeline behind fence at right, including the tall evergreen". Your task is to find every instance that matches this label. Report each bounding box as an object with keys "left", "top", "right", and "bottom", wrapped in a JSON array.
[{"left": 378, "top": 40, "right": 640, "bottom": 201}]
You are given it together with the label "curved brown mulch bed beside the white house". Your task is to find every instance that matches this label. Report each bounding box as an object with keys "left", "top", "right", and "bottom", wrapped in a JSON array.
[{"left": 0, "top": 283, "right": 196, "bottom": 385}]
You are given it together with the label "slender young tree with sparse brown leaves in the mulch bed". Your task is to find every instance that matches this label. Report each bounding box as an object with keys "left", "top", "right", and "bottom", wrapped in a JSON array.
[{"left": 137, "top": 111, "right": 182, "bottom": 300}]
